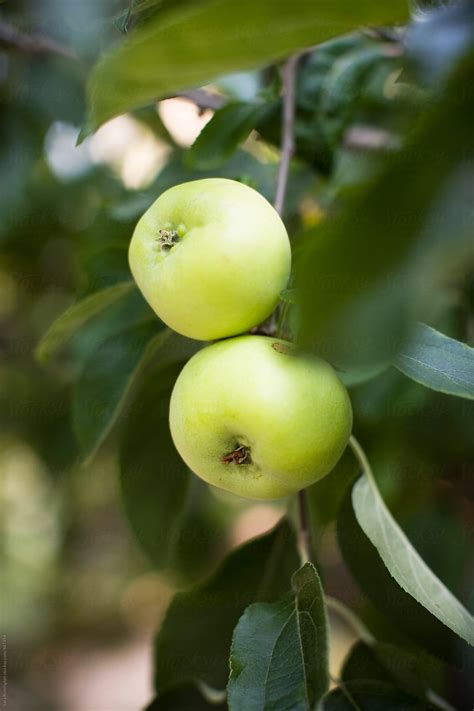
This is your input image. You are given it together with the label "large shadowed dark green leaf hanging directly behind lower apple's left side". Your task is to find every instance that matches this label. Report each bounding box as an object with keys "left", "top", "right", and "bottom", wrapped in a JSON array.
[{"left": 120, "top": 331, "right": 226, "bottom": 581}]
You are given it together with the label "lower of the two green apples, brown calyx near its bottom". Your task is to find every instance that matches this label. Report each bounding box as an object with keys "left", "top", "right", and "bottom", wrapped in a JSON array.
[{"left": 170, "top": 336, "right": 352, "bottom": 499}]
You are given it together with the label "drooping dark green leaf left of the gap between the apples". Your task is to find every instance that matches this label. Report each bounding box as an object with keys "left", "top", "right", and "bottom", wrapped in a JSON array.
[{"left": 73, "top": 320, "right": 170, "bottom": 460}]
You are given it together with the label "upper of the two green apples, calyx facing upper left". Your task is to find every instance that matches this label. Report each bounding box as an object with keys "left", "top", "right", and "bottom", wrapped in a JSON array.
[{"left": 129, "top": 178, "right": 291, "bottom": 341}]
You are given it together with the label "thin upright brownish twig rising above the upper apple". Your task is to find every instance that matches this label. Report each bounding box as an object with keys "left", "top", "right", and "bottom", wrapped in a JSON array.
[{"left": 274, "top": 54, "right": 299, "bottom": 215}]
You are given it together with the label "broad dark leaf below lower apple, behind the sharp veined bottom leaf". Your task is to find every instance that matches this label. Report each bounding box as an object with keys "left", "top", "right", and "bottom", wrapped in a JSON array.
[{"left": 155, "top": 520, "right": 299, "bottom": 693}]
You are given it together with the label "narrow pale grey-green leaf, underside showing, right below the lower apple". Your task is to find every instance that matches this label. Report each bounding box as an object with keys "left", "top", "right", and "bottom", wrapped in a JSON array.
[{"left": 352, "top": 476, "right": 474, "bottom": 645}]
